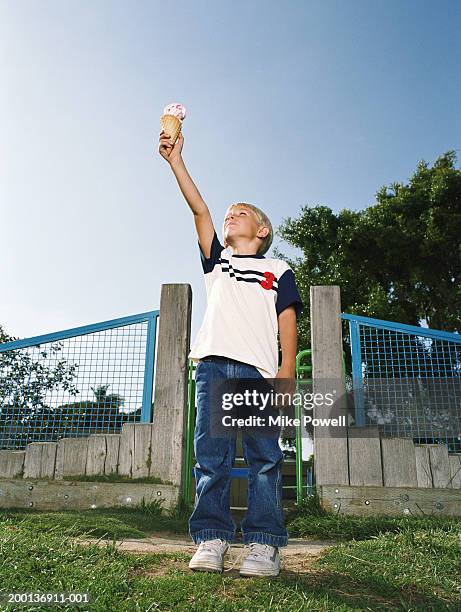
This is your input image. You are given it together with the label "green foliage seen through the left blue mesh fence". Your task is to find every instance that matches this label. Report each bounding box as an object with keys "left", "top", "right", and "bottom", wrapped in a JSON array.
[{"left": 0, "top": 326, "right": 137, "bottom": 448}]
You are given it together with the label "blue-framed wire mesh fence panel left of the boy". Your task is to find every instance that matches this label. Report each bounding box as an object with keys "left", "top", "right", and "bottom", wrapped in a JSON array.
[{"left": 0, "top": 310, "right": 160, "bottom": 449}]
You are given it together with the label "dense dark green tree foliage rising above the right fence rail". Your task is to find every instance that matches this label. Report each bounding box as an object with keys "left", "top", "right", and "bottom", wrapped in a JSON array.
[{"left": 275, "top": 151, "right": 461, "bottom": 354}]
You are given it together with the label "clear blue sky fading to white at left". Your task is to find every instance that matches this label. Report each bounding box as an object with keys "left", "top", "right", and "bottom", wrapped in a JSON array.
[{"left": 0, "top": 0, "right": 461, "bottom": 337}]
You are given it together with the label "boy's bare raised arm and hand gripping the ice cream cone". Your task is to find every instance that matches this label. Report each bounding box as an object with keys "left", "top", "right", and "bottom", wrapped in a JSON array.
[{"left": 159, "top": 130, "right": 215, "bottom": 258}]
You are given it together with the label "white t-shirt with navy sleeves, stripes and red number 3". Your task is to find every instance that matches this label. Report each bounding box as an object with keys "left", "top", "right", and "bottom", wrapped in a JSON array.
[{"left": 188, "top": 232, "right": 303, "bottom": 378}]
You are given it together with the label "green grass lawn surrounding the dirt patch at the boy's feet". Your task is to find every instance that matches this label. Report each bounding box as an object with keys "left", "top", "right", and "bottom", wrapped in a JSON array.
[{"left": 0, "top": 498, "right": 461, "bottom": 612}]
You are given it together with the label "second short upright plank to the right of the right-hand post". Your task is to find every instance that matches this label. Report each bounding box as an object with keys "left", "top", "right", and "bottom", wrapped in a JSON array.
[{"left": 381, "top": 438, "right": 418, "bottom": 487}]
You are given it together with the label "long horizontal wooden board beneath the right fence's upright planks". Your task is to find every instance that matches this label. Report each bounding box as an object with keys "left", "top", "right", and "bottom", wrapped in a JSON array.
[{"left": 319, "top": 485, "right": 461, "bottom": 516}]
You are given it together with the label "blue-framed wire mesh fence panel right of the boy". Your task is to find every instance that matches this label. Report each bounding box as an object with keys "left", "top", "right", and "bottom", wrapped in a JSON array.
[{"left": 341, "top": 313, "right": 461, "bottom": 452}]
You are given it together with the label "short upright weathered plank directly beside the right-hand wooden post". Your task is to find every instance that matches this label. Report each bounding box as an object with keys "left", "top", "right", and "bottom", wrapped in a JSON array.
[{"left": 348, "top": 427, "right": 383, "bottom": 486}]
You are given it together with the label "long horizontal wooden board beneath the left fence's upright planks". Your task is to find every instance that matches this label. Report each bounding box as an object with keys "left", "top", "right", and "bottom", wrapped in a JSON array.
[{"left": 0, "top": 479, "right": 179, "bottom": 510}]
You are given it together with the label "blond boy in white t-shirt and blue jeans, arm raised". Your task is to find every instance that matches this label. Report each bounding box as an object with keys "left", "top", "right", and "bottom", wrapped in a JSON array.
[{"left": 159, "top": 131, "right": 302, "bottom": 576}]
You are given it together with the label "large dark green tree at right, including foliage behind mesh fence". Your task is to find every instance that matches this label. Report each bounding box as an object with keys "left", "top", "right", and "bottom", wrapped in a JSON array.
[{"left": 275, "top": 151, "right": 461, "bottom": 448}]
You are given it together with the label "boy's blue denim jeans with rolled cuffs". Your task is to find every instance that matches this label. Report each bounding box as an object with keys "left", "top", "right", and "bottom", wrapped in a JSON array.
[{"left": 189, "top": 357, "right": 288, "bottom": 546}]
